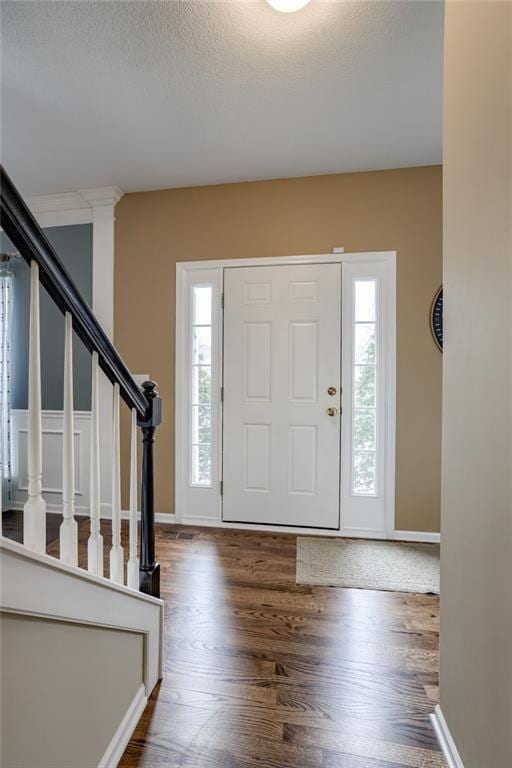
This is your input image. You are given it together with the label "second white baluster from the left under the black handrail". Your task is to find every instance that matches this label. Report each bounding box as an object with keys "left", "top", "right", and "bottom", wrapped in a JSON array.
[{"left": 60, "top": 312, "right": 78, "bottom": 565}]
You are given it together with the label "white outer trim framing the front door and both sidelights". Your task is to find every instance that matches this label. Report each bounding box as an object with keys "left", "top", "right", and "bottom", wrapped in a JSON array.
[{"left": 175, "top": 251, "right": 396, "bottom": 539}]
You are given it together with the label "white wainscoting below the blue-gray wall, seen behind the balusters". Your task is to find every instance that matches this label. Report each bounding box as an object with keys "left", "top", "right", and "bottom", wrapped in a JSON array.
[{"left": 11, "top": 410, "right": 91, "bottom": 514}]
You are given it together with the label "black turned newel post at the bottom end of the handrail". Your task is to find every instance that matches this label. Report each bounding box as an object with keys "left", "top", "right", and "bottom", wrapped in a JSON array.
[{"left": 137, "top": 381, "right": 162, "bottom": 597}]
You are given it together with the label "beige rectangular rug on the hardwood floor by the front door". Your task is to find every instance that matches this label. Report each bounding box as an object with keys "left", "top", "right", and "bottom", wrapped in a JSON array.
[{"left": 296, "top": 536, "right": 439, "bottom": 595}]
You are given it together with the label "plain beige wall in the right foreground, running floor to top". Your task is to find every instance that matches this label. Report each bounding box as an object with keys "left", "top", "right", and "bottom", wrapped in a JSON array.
[{"left": 441, "top": 1, "right": 512, "bottom": 768}]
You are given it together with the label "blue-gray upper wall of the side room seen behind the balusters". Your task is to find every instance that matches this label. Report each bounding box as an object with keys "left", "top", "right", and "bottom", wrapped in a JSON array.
[{"left": 1, "top": 224, "right": 92, "bottom": 411}]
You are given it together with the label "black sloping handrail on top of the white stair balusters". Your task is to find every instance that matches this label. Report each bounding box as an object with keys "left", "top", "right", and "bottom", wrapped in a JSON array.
[{"left": 0, "top": 166, "right": 149, "bottom": 418}]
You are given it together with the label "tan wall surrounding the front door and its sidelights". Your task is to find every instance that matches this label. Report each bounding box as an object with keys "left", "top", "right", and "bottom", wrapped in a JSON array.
[{"left": 115, "top": 166, "right": 442, "bottom": 531}]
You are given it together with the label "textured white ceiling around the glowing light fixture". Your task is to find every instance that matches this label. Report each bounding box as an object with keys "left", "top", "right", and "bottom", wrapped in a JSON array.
[{"left": 2, "top": 0, "right": 443, "bottom": 194}]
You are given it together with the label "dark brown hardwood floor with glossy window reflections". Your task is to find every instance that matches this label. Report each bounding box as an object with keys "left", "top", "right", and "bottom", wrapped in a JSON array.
[{"left": 3, "top": 515, "right": 445, "bottom": 768}]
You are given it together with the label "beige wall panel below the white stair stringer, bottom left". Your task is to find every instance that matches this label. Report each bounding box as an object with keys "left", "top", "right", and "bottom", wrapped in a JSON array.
[{"left": 1, "top": 613, "right": 143, "bottom": 768}]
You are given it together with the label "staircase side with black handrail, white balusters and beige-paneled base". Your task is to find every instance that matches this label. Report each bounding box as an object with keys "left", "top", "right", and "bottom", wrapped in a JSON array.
[{"left": 0, "top": 168, "right": 163, "bottom": 768}]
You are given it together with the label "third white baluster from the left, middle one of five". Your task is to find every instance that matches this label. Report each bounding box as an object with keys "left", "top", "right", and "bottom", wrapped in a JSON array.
[{"left": 87, "top": 352, "right": 103, "bottom": 576}]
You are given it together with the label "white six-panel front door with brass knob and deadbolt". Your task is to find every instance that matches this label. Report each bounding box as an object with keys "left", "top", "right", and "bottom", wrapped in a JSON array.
[{"left": 222, "top": 264, "right": 341, "bottom": 529}]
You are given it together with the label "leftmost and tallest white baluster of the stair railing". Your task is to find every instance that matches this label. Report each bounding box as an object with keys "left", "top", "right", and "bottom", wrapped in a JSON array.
[{"left": 23, "top": 261, "right": 46, "bottom": 553}]
